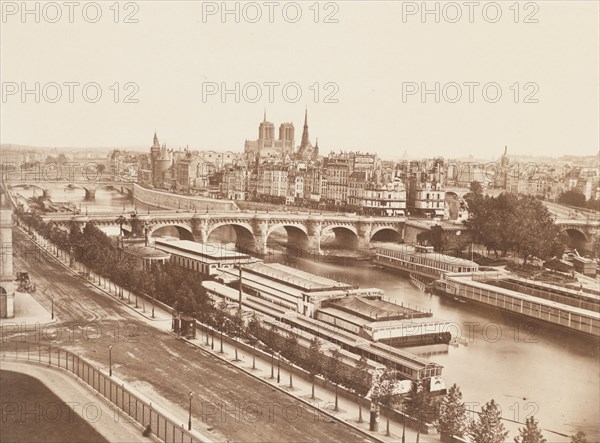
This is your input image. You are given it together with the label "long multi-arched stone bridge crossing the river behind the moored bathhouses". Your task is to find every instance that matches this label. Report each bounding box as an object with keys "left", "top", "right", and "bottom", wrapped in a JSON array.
[{"left": 42, "top": 211, "right": 405, "bottom": 254}]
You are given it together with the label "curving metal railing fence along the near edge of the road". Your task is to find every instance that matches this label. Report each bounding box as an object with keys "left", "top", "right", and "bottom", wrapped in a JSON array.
[{"left": 2, "top": 343, "right": 201, "bottom": 443}]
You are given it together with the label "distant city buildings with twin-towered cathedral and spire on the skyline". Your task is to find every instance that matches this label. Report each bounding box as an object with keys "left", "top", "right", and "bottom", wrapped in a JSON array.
[{"left": 2, "top": 111, "right": 600, "bottom": 220}]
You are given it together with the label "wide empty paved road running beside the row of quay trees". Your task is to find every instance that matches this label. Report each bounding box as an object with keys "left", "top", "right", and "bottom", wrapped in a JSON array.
[{"left": 4, "top": 230, "right": 376, "bottom": 442}]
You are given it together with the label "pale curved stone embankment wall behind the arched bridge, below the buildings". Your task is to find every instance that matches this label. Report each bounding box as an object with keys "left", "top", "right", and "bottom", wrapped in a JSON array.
[{"left": 133, "top": 184, "right": 238, "bottom": 211}]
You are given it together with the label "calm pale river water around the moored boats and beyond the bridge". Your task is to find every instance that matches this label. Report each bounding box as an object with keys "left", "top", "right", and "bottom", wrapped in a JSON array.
[{"left": 30, "top": 189, "right": 600, "bottom": 443}]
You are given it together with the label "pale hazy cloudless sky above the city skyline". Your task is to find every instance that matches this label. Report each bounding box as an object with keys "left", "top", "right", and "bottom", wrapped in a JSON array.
[{"left": 1, "top": 1, "right": 600, "bottom": 159}]
